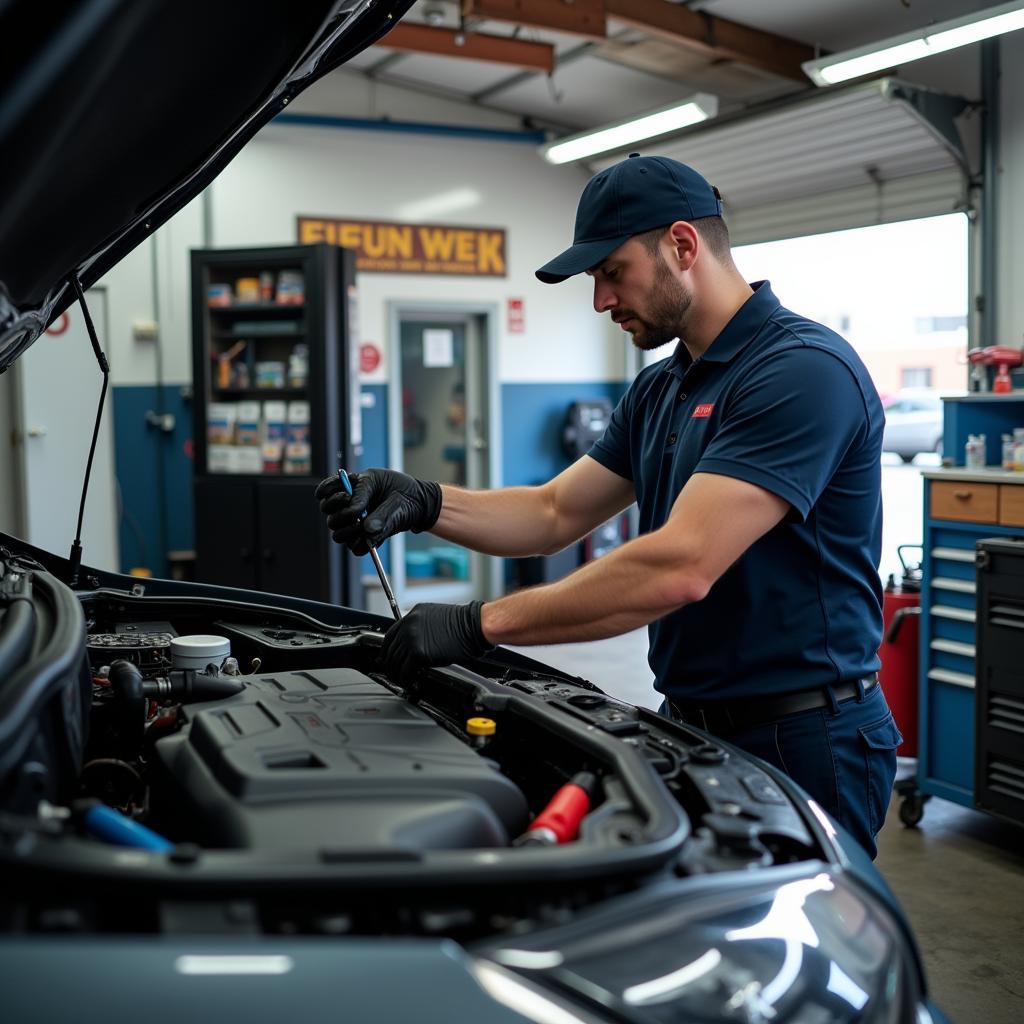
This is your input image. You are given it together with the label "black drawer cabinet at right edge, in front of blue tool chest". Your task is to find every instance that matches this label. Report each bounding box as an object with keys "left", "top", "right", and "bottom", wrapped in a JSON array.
[{"left": 974, "top": 538, "right": 1024, "bottom": 824}]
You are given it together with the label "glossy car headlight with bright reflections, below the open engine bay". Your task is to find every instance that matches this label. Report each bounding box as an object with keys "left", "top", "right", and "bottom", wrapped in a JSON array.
[{"left": 477, "top": 865, "right": 927, "bottom": 1024}]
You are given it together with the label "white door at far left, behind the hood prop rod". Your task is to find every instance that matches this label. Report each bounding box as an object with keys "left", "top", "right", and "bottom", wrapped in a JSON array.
[{"left": 14, "top": 289, "right": 120, "bottom": 572}]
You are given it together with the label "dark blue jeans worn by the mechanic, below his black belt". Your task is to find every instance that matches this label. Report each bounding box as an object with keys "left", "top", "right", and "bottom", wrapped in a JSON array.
[{"left": 663, "top": 685, "right": 903, "bottom": 860}]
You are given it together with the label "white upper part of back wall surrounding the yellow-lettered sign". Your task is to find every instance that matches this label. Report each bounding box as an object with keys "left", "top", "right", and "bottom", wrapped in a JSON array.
[{"left": 102, "top": 117, "right": 625, "bottom": 385}]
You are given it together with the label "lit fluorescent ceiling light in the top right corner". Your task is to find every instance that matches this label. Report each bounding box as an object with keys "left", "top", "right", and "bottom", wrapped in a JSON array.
[{"left": 803, "top": 0, "right": 1024, "bottom": 85}]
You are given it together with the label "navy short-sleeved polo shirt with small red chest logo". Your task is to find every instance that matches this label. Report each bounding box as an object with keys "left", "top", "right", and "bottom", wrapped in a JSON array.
[{"left": 590, "top": 282, "right": 885, "bottom": 699}]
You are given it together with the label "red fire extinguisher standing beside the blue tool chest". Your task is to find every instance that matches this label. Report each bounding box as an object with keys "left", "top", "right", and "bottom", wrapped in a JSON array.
[{"left": 879, "top": 544, "right": 924, "bottom": 758}]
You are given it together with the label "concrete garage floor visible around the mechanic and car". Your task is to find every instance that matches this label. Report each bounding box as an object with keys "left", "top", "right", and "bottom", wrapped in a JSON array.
[{"left": 507, "top": 630, "right": 1024, "bottom": 1024}]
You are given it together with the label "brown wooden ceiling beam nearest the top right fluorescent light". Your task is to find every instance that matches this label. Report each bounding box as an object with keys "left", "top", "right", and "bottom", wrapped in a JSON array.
[{"left": 604, "top": 0, "right": 818, "bottom": 85}]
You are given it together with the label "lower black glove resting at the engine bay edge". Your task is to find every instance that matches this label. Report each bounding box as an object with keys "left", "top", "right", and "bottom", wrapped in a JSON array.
[{"left": 383, "top": 601, "right": 493, "bottom": 679}]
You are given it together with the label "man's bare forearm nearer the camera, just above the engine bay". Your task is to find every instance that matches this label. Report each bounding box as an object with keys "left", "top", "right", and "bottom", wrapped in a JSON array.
[{"left": 481, "top": 532, "right": 710, "bottom": 644}]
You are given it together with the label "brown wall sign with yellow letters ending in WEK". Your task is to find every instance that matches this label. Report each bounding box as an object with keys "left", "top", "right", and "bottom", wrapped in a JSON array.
[{"left": 296, "top": 216, "right": 508, "bottom": 278}]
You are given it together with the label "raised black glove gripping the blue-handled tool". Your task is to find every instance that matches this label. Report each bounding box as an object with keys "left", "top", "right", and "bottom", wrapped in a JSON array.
[{"left": 313, "top": 469, "right": 441, "bottom": 555}]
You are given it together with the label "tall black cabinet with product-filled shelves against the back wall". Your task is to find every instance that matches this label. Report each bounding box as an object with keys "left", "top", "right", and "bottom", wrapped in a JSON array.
[{"left": 191, "top": 245, "right": 364, "bottom": 607}]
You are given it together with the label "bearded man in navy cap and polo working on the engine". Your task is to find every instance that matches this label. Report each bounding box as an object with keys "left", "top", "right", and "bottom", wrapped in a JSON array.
[{"left": 316, "top": 154, "right": 902, "bottom": 857}]
